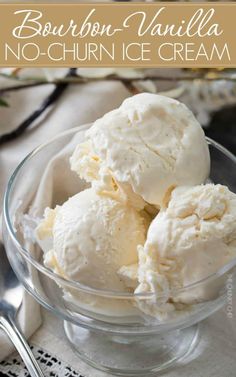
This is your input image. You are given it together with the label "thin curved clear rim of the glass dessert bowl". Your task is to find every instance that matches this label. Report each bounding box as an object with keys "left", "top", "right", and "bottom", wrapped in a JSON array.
[{"left": 3, "top": 123, "right": 236, "bottom": 299}]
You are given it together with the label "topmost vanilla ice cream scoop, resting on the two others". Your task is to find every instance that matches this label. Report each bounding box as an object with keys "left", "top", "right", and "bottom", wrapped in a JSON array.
[{"left": 71, "top": 93, "right": 210, "bottom": 206}]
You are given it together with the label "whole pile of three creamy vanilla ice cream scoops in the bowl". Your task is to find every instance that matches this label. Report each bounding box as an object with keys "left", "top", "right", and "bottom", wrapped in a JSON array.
[{"left": 37, "top": 93, "right": 236, "bottom": 319}]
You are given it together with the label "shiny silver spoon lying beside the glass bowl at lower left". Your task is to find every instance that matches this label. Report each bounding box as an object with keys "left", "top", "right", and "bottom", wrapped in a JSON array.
[{"left": 0, "top": 243, "right": 44, "bottom": 377}]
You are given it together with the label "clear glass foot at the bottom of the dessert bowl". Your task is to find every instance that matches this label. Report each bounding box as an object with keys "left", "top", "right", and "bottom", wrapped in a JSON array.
[{"left": 64, "top": 321, "right": 198, "bottom": 377}]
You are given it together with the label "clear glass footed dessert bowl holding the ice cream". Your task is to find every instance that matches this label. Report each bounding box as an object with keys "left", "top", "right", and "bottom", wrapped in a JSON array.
[{"left": 3, "top": 125, "right": 236, "bottom": 376}]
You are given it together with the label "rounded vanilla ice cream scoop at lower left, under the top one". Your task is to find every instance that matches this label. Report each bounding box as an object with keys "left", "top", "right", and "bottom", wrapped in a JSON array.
[{"left": 37, "top": 188, "right": 148, "bottom": 291}]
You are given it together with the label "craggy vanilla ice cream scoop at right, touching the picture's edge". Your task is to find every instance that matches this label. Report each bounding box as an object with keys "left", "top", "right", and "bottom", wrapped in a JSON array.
[{"left": 136, "top": 184, "right": 236, "bottom": 315}]
